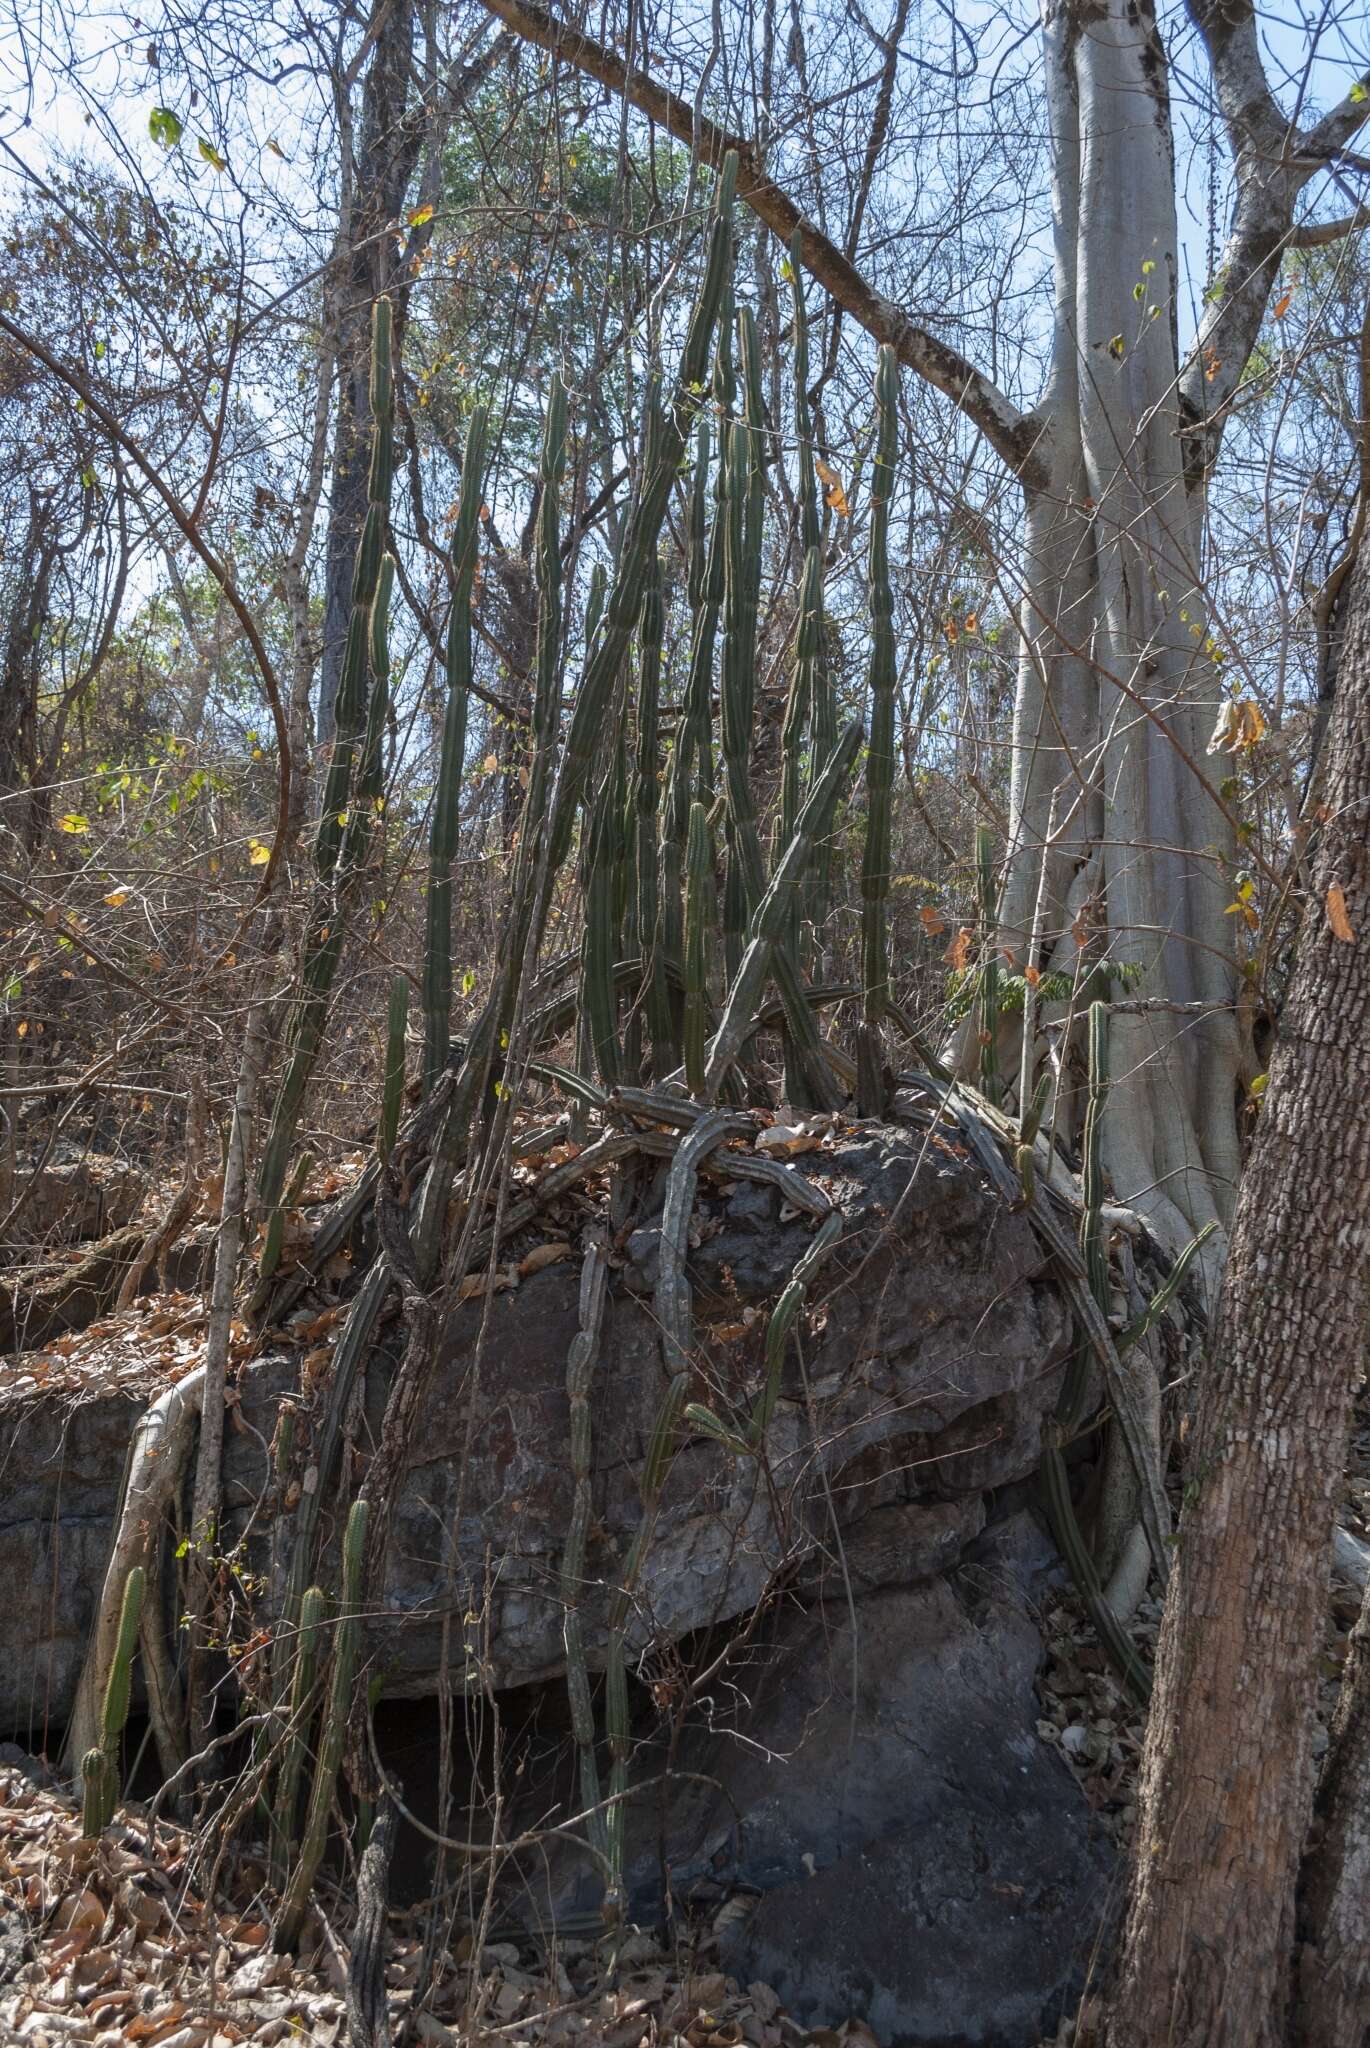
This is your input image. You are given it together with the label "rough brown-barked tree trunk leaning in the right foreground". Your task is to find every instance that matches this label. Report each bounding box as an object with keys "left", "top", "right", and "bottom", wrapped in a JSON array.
[{"left": 1108, "top": 536, "right": 1370, "bottom": 2048}]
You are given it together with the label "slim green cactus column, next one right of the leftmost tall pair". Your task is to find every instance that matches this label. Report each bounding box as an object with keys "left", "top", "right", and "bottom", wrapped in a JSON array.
[{"left": 424, "top": 408, "right": 497, "bottom": 1094}]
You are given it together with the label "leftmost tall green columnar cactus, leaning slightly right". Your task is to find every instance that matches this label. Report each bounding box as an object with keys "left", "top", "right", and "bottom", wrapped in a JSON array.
[{"left": 258, "top": 299, "right": 395, "bottom": 1280}]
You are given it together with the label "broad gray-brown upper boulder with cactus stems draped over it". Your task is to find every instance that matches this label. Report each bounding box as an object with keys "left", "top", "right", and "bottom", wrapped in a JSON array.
[{"left": 0, "top": 1124, "right": 1069, "bottom": 1741}]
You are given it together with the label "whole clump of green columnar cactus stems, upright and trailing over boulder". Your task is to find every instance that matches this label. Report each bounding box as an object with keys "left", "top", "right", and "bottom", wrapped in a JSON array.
[{"left": 248, "top": 158, "right": 982, "bottom": 1942}]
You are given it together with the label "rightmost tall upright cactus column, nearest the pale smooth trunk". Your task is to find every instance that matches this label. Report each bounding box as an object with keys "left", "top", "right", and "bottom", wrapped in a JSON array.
[{"left": 856, "top": 346, "right": 899, "bottom": 1116}]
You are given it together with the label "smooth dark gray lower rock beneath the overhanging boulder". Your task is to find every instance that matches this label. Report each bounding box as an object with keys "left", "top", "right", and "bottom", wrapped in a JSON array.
[{"left": 518, "top": 1509, "right": 1112, "bottom": 2048}]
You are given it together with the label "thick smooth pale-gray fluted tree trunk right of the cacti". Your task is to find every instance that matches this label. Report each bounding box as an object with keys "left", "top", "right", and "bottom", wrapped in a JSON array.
[{"left": 1003, "top": 0, "right": 1237, "bottom": 1278}]
